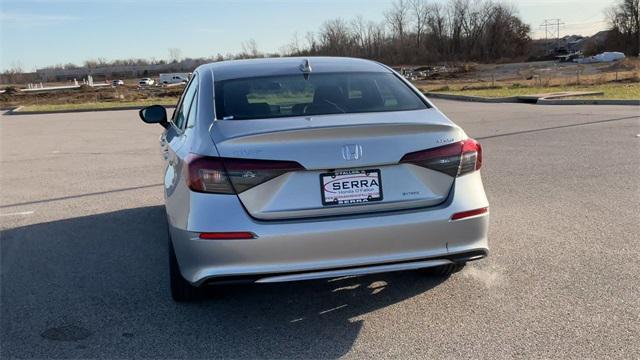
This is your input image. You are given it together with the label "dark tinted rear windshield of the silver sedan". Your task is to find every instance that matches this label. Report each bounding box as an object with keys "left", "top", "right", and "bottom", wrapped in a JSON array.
[{"left": 215, "top": 72, "right": 428, "bottom": 120}]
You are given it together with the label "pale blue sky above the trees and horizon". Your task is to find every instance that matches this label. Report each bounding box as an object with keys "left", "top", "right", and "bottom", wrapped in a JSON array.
[{"left": 0, "top": 0, "right": 614, "bottom": 71}]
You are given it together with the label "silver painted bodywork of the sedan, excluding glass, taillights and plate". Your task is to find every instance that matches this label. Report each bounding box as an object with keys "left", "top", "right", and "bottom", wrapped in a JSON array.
[{"left": 154, "top": 58, "right": 489, "bottom": 285}]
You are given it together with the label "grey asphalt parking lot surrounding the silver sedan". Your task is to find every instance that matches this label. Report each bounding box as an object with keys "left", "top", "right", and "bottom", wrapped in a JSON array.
[{"left": 0, "top": 101, "right": 640, "bottom": 359}]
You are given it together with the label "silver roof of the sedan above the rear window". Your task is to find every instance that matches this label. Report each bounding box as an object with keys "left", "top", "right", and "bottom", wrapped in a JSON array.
[{"left": 200, "top": 56, "right": 390, "bottom": 81}]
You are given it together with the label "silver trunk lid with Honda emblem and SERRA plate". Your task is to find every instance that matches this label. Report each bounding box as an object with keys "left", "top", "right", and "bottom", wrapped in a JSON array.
[{"left": 211, "top": 109, "right": 465, "bottom": 220}]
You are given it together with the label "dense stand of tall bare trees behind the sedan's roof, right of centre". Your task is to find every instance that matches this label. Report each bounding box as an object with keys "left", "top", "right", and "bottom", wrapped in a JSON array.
[{"left": 285, "top": 0, "right": 531, "bottom": 65}]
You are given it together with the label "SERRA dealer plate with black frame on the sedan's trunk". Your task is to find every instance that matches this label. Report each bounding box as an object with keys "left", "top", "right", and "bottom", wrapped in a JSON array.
[{"left": 320, "top": 169, "right": 384, "bottom": 206}]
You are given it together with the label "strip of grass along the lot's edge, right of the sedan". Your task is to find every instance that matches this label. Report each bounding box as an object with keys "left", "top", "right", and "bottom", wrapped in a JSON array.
[{"left": 424, "top": 83, "right": 640, "bottom": 99}]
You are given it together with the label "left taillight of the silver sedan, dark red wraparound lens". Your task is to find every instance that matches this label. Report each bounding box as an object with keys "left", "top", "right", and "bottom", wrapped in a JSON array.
[{"left": 186, "top": 154, "right": 304, "bottom": 194}]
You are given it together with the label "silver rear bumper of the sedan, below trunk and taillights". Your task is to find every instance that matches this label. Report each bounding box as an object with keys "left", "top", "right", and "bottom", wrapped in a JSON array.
[{"left": 168, "top": 172, "right": 489, "bottom": 285}]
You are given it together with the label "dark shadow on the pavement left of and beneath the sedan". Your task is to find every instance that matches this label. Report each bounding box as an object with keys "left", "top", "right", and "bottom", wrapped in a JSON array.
[{"left": 0, "top": 206, "right": 442, "bottom": 358}]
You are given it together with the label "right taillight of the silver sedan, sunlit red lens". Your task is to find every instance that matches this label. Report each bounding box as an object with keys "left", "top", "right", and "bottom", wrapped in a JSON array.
[{"left": 400, "top": 138, "right": 482, "bottom": 177}]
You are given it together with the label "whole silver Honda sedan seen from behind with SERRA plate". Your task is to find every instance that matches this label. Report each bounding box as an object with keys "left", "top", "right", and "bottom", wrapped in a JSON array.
[{"left": 140, "top": 57, "right": 489, "bottom": 301}]
